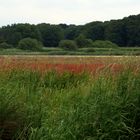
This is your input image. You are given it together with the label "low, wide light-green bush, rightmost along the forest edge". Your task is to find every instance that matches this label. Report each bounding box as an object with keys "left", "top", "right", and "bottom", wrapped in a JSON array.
[{"left": 92, "top": 40, "right": 119, "bottom": 48}]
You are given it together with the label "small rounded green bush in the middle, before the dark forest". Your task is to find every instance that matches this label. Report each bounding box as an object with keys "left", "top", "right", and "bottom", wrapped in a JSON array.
[{"left": 59, "top": 40, "right": 77, "bottom": 51}]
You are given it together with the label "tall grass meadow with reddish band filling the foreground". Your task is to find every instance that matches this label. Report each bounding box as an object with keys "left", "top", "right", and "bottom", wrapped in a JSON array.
[{"left": 0, "top": 55, "right": 140, "bottom": 140}]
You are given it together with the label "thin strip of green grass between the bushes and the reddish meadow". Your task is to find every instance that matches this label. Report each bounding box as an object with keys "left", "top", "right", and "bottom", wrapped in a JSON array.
[{"left": 0, "top": 47, "right": 140, "bottom": 55}]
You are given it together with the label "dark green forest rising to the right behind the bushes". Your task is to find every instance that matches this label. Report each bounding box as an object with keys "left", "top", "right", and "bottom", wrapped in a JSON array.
[{"left": 0, "top": 14, "right": 140, "bottom": 47}]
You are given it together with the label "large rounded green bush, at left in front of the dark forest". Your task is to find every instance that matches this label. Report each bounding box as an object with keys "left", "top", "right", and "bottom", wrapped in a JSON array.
[{"left": 18, "top": 38, "right": 42, "bottom": 51}]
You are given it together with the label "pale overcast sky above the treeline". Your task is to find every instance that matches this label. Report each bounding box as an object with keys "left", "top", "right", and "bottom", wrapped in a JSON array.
[{"left": 0, "top": 0, "right": 140, "bottom": 26}]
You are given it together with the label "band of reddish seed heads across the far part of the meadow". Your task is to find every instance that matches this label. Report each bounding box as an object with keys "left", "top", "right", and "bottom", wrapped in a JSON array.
[{"left": 0, "top": 57, "right": 138, "bottom": 74}]
